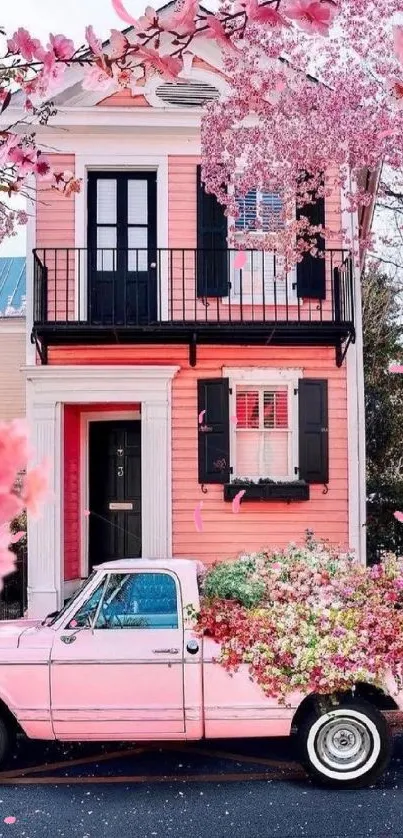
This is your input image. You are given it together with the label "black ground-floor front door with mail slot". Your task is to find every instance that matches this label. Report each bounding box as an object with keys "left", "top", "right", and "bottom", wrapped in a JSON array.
[{"left": 89, "top": 421, "right": 141, "bottom": 568}]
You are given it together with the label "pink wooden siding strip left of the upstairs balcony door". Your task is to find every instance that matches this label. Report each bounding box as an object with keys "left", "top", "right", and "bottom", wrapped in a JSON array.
[{"left": 36, "top": 154, "right": 75, "bottom": 320}]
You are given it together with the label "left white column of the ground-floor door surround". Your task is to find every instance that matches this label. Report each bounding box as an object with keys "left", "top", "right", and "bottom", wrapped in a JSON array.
[{"left": 27, "top": 382, "right": 62, "bottom": 617}]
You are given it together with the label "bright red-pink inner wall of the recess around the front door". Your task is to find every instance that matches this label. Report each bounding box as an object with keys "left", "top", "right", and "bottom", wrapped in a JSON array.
[{"left": 79, "top": 410, "right": 141, "bottom": 578}]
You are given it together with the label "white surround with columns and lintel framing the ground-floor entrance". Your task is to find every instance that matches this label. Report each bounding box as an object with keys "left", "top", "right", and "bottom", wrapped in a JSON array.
[{"left": 24, "top": 366, "right": 179, "bottom": 617}]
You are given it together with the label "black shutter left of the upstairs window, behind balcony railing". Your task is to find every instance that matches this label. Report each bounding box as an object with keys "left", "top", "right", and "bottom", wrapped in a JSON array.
[{"left": 197, "top": 166, "right": 229, "bottom": 297}]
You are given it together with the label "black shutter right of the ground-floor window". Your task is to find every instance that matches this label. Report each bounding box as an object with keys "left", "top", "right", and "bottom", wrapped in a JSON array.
[{"left": 298, "top": 378, "right": 329, "bottom": 483}]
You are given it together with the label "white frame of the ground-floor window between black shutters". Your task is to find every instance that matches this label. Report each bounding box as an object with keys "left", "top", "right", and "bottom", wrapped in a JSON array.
[{"left": 223, "top": 367, "right": 303, "bottom": 483}]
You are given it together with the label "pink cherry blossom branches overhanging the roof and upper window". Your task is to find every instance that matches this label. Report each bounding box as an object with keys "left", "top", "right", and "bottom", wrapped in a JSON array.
[{"left": 0, "top": 0, "right": 403, "bottom": 259}]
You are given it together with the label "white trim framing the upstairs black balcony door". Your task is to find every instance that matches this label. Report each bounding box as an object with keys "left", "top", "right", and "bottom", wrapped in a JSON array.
[{"left": 74, "top": 152, "right": 168, "bottom": 320}]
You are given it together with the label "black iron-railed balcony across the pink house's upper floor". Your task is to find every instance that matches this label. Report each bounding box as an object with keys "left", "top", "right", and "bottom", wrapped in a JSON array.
[{"left": 32, "top": 248, "right": 355, "bottom": 366}]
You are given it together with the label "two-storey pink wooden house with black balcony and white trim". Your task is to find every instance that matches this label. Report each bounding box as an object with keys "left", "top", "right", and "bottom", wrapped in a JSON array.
[{"left": 7, "top": 4, "right": 372, "bottom": 615}]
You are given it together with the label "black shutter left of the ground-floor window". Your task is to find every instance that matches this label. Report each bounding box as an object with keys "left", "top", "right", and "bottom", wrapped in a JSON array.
[{"left": 197, "top": 378, "right": 230, "bottom": 483}]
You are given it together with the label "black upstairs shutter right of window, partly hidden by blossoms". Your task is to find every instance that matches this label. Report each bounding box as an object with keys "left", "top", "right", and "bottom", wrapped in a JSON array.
[{"left": 297, "top": 176, "right": 326, "bottom": 300}]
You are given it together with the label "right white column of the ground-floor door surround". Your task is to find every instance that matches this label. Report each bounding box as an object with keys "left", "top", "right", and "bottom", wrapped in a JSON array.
[{"left": 141, "top": 394, "right": 172, "bottom": 559}]
